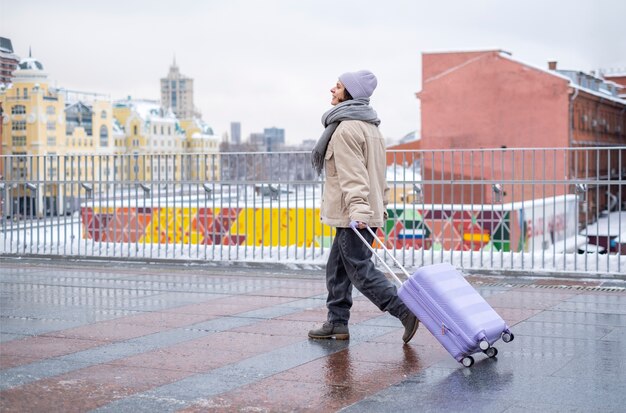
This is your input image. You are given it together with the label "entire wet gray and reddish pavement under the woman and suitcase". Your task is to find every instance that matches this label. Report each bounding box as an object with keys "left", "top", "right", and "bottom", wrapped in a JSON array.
[{"left": 0, "top": 260, "right": 626, "bottom": 413}]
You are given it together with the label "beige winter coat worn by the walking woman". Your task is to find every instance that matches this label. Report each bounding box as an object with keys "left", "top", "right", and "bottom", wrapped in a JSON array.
[{"left": 320, "top": 120, "right": 389, "bottom": 227}]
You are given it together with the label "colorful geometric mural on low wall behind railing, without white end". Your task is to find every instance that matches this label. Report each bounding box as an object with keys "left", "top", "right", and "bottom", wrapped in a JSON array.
[{"left": 81, "top": 207, "right": 511, "bottom": 251}]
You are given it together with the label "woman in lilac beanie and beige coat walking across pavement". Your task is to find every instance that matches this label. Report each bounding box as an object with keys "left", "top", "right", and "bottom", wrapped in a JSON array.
[{"left": 309, "top": 70, "right": 419, "bottom": 343}]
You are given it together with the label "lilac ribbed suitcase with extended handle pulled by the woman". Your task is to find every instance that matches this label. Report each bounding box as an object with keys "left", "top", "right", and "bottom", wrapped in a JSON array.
[{"left": 355, "top": 228, "right": 513, "bottom": 367}]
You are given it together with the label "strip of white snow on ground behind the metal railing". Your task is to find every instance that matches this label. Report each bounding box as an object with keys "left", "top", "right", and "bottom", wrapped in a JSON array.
[{"left": 0, "top": 219, "right": 626, "bottom": 278}]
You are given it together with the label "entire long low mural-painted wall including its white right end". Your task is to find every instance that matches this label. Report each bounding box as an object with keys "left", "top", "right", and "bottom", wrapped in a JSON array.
[{"left": 81, "top": 196, "right": 576, "bottom": 252}]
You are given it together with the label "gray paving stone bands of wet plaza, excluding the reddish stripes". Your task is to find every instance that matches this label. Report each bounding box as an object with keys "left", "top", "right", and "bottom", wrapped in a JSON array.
[{"left": 0, "top": 265, "right": 626, "bottom": 413}]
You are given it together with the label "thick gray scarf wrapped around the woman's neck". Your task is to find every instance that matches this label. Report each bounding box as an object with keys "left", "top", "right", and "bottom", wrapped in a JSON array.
[{"left": 311, "top": 98, "right": 380, "bottom": 175}]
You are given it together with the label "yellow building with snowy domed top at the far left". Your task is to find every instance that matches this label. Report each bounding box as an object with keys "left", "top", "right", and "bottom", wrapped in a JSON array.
[{"left": 0, "top": 57, "right": 115, "bottom": 216}]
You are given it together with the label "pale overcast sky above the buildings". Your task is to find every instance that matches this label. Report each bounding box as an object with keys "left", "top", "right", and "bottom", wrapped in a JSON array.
[{"left": 0, "top": 0, "right": 626, "bottom": 143}]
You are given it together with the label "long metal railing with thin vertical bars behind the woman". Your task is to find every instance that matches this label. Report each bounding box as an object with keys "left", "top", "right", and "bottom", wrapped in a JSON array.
[{"left": 0, "top": 147, "right": 626, "bottom": 277}]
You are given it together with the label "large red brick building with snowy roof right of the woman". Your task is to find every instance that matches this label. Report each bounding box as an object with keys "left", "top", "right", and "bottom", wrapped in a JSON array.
[{"left": 390, "top": 50, "right": 626, "bottom": 210}]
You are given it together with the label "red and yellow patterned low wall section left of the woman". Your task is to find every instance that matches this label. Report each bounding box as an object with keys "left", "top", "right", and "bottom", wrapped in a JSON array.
[{"left": 81, "top": 206, "right": 332, "bottom": 246}]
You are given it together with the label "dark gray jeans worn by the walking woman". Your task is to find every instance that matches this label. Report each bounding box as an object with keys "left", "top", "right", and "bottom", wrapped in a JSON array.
[{"left": 326, "top": 228, "right": 409, "bottom": 324}]
